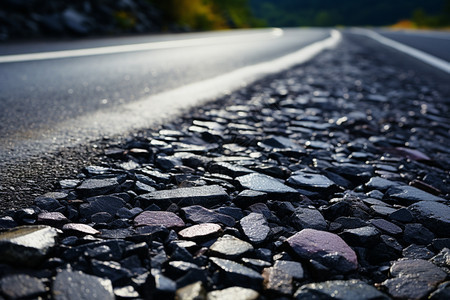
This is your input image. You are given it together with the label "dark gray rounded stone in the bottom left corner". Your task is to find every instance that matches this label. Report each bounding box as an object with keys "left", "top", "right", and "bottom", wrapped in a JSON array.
[{"left": 0, "top": 274, "right": 47, "bottom": 299}]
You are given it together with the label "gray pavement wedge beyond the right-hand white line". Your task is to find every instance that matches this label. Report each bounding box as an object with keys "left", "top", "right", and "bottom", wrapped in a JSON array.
[{"left": 377, "top": 30, "right": 450, "bottom": 62}]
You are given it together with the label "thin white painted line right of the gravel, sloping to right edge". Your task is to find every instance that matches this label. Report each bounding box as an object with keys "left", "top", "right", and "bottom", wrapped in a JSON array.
[{"left": 354, "top": 28, "right": 450, "bottom": 74}]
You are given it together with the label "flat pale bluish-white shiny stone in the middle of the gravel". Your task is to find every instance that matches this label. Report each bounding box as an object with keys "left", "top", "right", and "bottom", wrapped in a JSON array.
[{"left": 236, "top": 173, "right": 299, "bottom": 197}]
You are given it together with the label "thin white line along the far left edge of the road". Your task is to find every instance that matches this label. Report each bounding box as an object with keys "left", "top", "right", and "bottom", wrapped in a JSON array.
[{"left": 0, "top": 28, "right": 284, "bottom": 63}]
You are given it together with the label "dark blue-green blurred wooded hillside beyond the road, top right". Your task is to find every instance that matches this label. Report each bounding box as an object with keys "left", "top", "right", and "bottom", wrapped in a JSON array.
[{"left": 250, "top": 0, "right": 450, "bottom": 27}]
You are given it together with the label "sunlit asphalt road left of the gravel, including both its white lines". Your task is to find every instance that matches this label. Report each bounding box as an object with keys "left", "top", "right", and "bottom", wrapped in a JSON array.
[{"left": 0, "top": 28, "right": 339, "bottom": 160}]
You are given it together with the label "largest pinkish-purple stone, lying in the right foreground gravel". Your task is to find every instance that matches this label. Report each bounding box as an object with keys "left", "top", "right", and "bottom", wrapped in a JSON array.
[{"left": 287, "top": 229, "right": 358, "bottom": 273}]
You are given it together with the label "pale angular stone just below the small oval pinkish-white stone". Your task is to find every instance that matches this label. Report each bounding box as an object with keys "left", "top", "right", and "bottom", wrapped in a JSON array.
[{"left": 209, "top": 234, "right": 253, "bottom": 259}]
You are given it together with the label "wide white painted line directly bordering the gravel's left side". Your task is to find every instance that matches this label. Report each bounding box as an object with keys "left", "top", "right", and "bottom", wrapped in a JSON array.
[{"left": 0, "top": 30, "right": 342, "bottom": 161}]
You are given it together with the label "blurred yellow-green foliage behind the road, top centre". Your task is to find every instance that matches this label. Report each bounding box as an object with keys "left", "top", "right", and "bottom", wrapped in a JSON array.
[{"left": 148, "top": 0, "right": 265, "bottom": 30}]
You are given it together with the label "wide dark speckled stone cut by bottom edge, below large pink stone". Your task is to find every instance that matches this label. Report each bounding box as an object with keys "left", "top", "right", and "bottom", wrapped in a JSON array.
[{"left": 294, "top": 279, "right": 389, "bottom": 300}]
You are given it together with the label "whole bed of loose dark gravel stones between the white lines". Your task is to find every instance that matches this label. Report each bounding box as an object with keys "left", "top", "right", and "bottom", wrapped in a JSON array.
[{"left": 0, "top": 36, "right": 450, "bottom": 300}]
